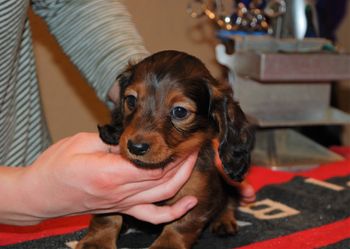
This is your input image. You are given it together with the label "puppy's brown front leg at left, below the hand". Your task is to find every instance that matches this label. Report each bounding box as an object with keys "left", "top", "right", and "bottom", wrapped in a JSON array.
[{"left": 76, "top": 214, "right": 123, "bottom": 249}]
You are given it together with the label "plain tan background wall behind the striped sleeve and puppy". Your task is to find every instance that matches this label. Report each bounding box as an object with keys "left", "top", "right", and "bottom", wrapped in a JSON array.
[{"left": 31, "top": 0, "right": 350, "bottom": 144}]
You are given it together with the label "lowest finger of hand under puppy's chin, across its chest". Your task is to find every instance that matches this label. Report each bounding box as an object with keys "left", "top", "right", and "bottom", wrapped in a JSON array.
[{"left": 123, "top": 196, "right": 197, "bottom": 224}]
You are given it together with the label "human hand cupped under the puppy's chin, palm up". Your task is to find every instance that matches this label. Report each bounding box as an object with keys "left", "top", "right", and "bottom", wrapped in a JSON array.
[{"left": 8, "top": 133, "right": 197, "bottom": 225}]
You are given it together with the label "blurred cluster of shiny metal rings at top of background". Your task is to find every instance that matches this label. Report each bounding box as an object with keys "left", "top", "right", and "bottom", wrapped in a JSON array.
[{"left": 187, "top": 0, "right": 286, "bottom": 36}]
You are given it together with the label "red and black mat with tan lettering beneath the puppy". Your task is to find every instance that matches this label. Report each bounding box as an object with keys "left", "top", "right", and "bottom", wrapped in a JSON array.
[{"left": 0, "top": 148, "right": 350, "bottom": 249}]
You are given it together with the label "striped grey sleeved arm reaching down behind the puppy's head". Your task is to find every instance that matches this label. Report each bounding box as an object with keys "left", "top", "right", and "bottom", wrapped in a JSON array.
[{"left": 33, "top": 0, "right": 148, "bottom": 106}]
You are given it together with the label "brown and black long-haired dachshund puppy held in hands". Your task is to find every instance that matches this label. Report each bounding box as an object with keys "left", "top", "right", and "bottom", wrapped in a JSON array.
[{"left": 77, "top": 51, "right": 254, "bottom": 249}]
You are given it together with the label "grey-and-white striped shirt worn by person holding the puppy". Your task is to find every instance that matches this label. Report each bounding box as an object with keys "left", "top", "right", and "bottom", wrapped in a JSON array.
[{"left": 0, "top": 0, "right": 148, "bottom": 166}]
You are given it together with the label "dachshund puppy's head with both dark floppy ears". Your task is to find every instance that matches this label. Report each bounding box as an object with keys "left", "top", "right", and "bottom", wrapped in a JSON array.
[{"left": 99, "top": 51, "right": 253, "bottom": 180}]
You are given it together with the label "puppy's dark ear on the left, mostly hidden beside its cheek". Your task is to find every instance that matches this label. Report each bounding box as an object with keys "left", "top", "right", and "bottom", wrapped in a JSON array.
[{"left": 97, "top": 65, "right": 132, "bottom": 145}]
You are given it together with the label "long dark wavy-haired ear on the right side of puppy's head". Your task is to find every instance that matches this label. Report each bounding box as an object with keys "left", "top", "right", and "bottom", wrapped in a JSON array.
[{"left": 211, "top": 89, "right": 255, "bottom": 181}]
